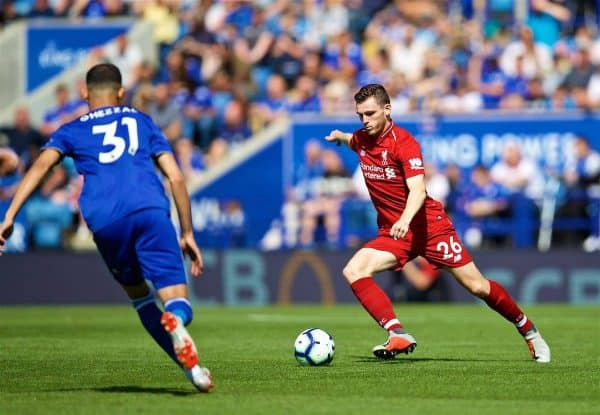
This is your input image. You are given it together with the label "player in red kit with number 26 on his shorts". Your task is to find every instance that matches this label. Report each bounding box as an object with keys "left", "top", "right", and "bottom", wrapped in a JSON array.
[{"left": 325, "top": 84, "right": 550, "bottom": 362}]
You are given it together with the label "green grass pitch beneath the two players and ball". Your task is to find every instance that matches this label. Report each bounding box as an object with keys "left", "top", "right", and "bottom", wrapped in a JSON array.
[{"left": 0, "top": 304, "right": 600, "bottom": 415}]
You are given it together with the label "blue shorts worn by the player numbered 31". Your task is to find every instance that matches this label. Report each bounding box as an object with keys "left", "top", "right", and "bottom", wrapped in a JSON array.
[{"left": 94, "top": 209, "right": 186, "bottom": 289}]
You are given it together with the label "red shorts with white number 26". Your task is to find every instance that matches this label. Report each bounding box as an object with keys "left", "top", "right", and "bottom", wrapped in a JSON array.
[{"left": 364, "top": 217, "right": 473, "bottom": 270}]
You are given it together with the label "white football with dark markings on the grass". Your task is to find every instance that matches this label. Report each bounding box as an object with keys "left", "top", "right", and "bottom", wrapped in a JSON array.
[{"left": 294, "top": 328, "right": 335, "bottom": 366}]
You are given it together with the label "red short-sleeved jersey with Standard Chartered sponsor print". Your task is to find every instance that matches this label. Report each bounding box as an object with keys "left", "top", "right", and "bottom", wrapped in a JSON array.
[{"left": 350, "top": 123, "right": 446, "bottom": 231}]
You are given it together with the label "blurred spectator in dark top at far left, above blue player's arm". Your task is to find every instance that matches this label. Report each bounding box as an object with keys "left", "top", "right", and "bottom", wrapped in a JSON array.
[{"left": 0, "top": 107, "right": 46, "bottom": 169}]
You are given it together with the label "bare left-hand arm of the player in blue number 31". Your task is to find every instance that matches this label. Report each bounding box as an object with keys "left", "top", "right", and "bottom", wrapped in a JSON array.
[{"left": 0, "top": 149, "right": 61, "bottom": 255}]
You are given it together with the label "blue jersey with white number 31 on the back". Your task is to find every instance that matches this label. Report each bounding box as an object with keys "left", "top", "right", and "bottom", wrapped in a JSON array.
[{"left": 43, "top": 106, "right": 171, "bottom": 231}]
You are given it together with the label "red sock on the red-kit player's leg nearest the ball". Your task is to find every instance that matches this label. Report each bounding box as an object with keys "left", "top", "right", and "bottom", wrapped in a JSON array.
[{"left": 350, "top": 277, "right": 402, "bottom": 331}]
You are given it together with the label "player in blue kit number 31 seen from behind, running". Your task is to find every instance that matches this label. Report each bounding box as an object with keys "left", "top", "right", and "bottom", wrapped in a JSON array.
[{"left": 0, "top": 63, "right": 213, "bottom": 392}]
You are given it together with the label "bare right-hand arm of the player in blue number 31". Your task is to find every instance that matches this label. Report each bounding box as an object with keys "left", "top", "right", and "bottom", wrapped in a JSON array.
[{"left": 156, "top": 153, "right": 204, "bottom": 277}]
